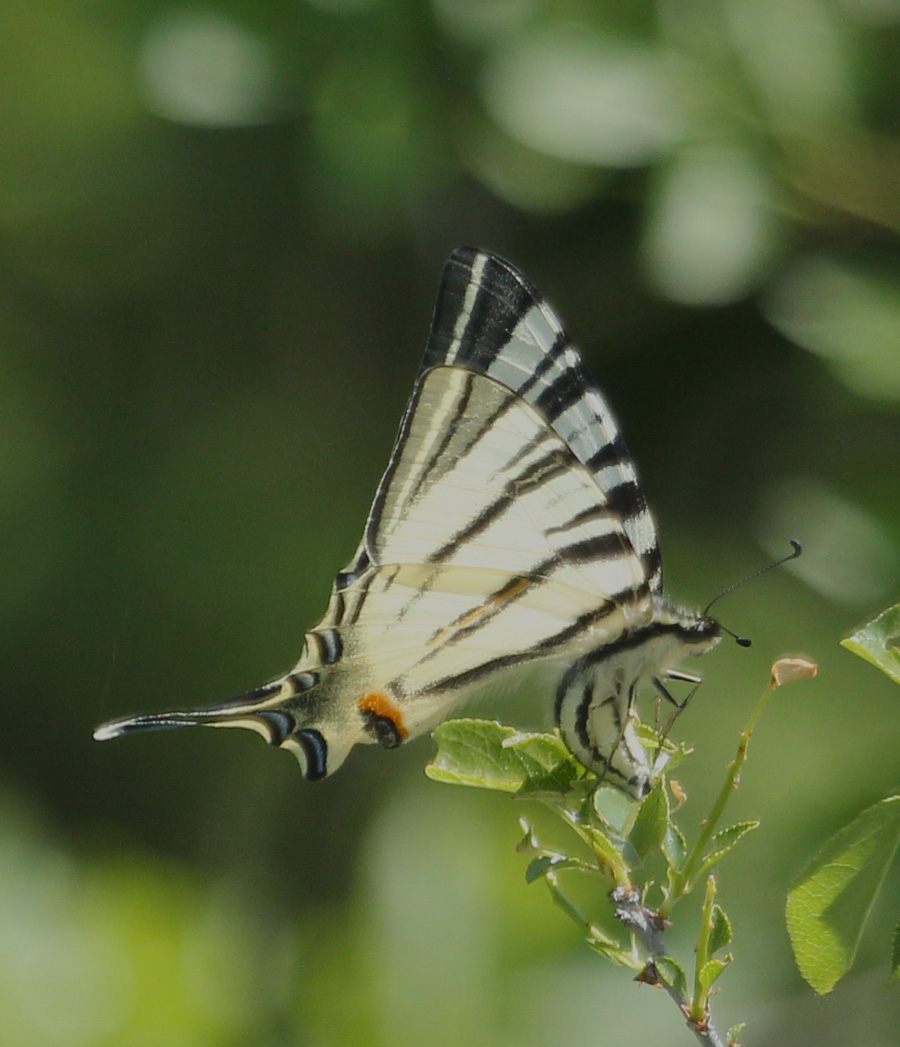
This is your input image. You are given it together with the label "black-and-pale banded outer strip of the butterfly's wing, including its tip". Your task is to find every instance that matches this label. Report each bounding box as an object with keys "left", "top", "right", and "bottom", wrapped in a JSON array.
[{"left": 420, "top": 247, "right": 662, "bottom": 592}]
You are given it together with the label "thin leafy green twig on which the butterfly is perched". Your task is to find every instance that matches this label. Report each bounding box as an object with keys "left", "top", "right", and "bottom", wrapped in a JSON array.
[{"left": 426, "top": 659, "right": 815, "bottom": 1047}]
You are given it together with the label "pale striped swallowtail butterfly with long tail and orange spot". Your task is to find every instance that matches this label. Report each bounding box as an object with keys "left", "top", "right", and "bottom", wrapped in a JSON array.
[{"left": 94, "top": 247, "right": 720, "bottom": 797}]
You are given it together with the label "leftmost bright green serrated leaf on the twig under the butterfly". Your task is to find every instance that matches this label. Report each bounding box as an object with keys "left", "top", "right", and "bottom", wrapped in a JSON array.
[{"left": 425, "top": 719, "right": 583, "bottom": 793}]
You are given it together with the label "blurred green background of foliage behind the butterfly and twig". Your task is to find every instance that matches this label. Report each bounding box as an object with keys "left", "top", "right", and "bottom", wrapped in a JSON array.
[{"left": 0, "top": 0, "right": 900, "bottom": 1047}]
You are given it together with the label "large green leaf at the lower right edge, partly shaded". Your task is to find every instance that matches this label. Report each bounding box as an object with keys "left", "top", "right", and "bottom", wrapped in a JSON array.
[{"left": 786, "top": 796, "right": 900, "bottom": 994}]
